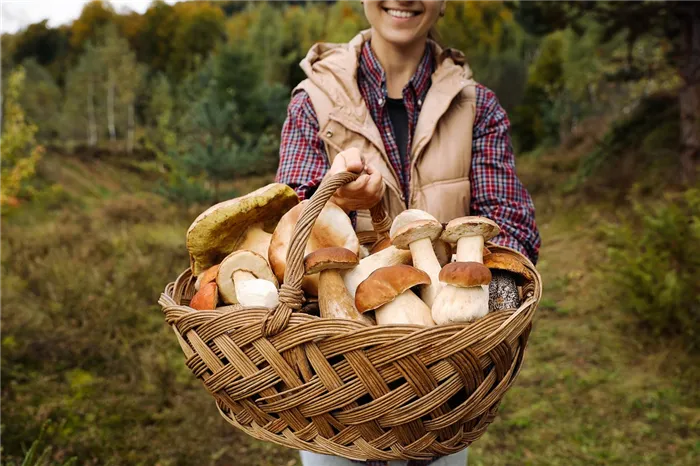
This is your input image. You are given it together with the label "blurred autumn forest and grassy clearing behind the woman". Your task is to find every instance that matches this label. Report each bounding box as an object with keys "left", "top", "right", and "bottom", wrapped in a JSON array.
[{"left": 0, "top": 0, "right": 700, "bottom": 466}]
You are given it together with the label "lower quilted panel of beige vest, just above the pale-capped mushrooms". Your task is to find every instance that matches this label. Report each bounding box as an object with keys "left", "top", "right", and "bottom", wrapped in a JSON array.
[{"left": 415, "top": 178, "right": 471, "bottom": 223}]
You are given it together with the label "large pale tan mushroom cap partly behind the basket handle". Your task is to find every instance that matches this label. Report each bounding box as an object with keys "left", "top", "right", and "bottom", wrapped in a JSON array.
[{"left": 268, "top": 199, "right": 360, "bottom": 296}]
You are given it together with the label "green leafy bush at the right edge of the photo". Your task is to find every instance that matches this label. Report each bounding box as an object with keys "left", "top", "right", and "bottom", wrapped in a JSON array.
[{"left": 602, "top": 188, "right": 700, "bottom": 351}]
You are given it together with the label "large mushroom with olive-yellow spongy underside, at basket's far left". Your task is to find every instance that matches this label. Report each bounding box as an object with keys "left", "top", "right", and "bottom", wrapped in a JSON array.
[{"left": 187, "top": 183, "right": 299, "bottom": 276}]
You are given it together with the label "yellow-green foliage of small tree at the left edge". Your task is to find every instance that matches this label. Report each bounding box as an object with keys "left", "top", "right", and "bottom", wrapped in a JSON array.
[{"left": 0, "top": 67, "right": 44, "bottom": 213}]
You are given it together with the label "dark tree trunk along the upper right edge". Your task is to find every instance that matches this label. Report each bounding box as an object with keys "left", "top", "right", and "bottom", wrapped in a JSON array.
[{"left": 679, "top": 6, "right": 700, "bottom": 184}]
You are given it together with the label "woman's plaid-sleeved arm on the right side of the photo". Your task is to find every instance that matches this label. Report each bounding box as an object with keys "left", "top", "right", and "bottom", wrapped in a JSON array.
[{"left": 470, "top": 85, "right": 541, "bottom": 264}]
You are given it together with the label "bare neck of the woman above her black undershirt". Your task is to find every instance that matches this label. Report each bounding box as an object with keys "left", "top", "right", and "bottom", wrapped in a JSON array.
[{"left": 370, "top": 34, "right": 426, "bottom": 99}]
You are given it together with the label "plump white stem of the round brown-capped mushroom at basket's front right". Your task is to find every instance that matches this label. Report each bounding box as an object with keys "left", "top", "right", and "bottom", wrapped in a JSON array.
[{"left": 432, "top": 285, "right": 489, "bottom": 325}]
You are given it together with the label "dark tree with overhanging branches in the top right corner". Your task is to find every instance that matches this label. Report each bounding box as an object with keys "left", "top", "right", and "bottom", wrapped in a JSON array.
[{"left": 508, "top": 0, "right": 700, "bottom": 182}]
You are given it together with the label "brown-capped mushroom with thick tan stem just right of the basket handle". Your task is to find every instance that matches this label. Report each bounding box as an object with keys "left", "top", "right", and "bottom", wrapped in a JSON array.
[{"left": 304, "top": 247, "right": 373, "bottom": 325}]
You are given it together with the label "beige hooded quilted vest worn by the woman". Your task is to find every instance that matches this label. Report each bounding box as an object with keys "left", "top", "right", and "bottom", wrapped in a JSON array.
[{"left": 293, "top": 30, "right": 476, "bottom": 240}]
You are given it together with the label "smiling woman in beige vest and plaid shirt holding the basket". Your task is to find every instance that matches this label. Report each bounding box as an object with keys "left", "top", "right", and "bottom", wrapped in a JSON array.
[{"left": 276, "top": 0, "right": 540, "bottom": 465}]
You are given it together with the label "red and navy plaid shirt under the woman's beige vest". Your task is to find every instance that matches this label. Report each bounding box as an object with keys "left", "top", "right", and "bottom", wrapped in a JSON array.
[{"left": 276, "top": 42, "right": 541, "bottom": 465}]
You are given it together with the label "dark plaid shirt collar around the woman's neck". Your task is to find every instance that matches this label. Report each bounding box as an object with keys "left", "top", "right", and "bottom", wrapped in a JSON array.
[{"left": 358, "top": 41, "right": 434, "bottom": 105}]
